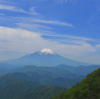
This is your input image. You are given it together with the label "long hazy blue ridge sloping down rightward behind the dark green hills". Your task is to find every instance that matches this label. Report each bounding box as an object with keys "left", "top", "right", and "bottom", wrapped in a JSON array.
[{"left": 11, "top": 66, "right": 84, "bottom": 79}]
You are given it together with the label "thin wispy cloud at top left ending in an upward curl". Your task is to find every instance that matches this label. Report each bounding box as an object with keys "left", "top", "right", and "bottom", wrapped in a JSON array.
[{"left": 0, "top": 4, "right": 38, "bottom": 15}]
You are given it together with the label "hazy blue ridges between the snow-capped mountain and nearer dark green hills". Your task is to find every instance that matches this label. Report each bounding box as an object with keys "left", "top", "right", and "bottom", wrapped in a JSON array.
[{"left": 0, "top": 65, "right": 100, "bottom": 88}]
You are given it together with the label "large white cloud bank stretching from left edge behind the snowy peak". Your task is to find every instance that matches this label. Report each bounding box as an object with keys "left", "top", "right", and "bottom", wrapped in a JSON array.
[{"left": 0, "top": 27, "right": 96, "bottom": 55}]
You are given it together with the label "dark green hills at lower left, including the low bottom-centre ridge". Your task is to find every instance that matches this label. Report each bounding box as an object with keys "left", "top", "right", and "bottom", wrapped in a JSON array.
[{"left": 0, "top": 73, "right": 67, "bottom": 99}]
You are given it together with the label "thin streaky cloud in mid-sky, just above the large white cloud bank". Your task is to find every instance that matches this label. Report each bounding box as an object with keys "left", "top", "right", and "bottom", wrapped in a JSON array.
[{"left": 17, "top": 17, "right": 74, "bottom": 29}]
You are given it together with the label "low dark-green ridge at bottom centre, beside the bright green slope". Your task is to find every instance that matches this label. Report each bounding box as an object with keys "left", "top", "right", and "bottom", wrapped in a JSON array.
[{"left": 19, "top": 86, "right": 67, "bottom": 99}]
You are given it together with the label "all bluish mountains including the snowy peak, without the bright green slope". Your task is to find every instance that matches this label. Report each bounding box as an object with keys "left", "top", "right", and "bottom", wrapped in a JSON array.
[{"left": 0, "top": 49, "right": 100, "bottom": 99}]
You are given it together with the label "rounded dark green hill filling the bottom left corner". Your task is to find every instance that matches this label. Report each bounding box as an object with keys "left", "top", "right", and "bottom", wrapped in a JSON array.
[{"left": 0, "top": 73, "right": 40, "bottom": 99}]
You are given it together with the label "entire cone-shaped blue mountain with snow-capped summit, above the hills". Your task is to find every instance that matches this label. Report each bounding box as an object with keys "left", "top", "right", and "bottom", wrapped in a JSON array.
[{"left": 4, "top": 49, "right": 90, "bottom": 66}]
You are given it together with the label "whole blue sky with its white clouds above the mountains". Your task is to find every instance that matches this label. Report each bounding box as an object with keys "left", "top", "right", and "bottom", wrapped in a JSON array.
[{"left": 0, "top": 0, "right": 100, "bottom": 64}]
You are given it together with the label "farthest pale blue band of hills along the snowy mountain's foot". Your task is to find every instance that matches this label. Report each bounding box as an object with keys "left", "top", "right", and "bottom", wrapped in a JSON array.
[{"left": 0, "top": 63, "right": 100, "bottom": 77}]
